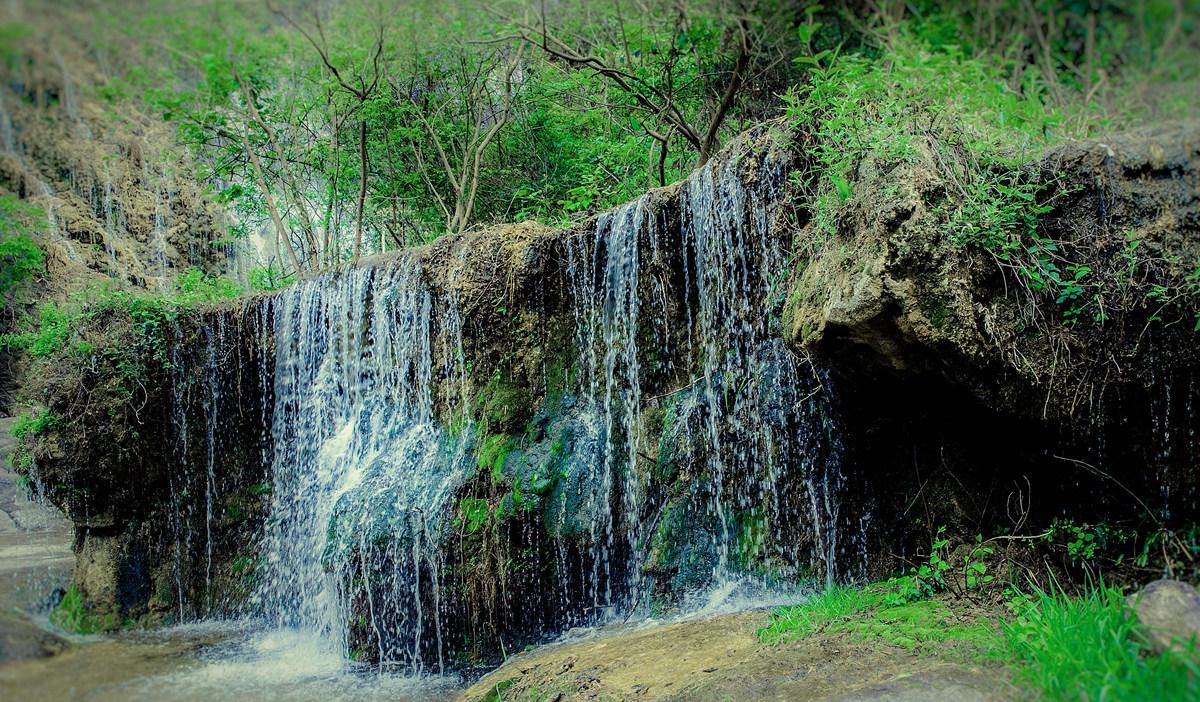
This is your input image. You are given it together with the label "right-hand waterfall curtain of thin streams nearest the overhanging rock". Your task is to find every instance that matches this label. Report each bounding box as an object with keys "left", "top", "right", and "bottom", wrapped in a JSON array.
[{"left": 566, "top": 139, "right": 842, "bottom": 604}]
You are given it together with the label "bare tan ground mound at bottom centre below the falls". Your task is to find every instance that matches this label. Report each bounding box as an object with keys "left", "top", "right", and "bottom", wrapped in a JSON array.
[{"left": 460, "top": 611, "right": 1019, "bottom": 702}]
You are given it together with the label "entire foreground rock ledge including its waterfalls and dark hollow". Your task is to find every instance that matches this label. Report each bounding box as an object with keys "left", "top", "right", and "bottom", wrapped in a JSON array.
[{"left": 16, "top": 120, "right": 1200, "bottom": 670}]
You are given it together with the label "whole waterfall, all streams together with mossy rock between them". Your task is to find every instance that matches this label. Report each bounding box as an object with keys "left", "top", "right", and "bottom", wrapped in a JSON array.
[{"left": 157, "top": 132, "right": 845, "bottom": 673}]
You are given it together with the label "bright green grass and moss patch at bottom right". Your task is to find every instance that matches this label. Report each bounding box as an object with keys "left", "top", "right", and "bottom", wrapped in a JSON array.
[{"left": 758, "top": 581, "right": 1200, "bottom": 702}]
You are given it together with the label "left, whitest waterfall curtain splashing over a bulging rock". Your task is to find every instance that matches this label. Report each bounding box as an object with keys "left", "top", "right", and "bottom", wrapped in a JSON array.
[{"left": 258, "top": 259, "right": 474, "bottom": 670}]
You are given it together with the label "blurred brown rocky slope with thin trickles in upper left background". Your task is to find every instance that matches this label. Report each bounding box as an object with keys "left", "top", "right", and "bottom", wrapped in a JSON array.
[{"left": 0, "top": 7, "right": 232, "bottom": 298}]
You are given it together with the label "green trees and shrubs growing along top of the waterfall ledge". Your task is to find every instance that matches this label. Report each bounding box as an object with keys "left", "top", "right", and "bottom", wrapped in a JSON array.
[{"left": 21, "top": 0, "right": 1200, "bottom": 284}]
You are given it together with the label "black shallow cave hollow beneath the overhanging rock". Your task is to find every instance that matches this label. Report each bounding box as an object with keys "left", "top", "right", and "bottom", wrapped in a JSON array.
[{"left": 826, "top": 333, "right": 1198, "bottom": 577}]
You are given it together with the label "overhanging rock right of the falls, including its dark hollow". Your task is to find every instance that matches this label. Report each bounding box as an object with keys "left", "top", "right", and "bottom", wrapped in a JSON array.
[{"left": 785, "top": 124, "right": 1200, "bottom": 564}]
